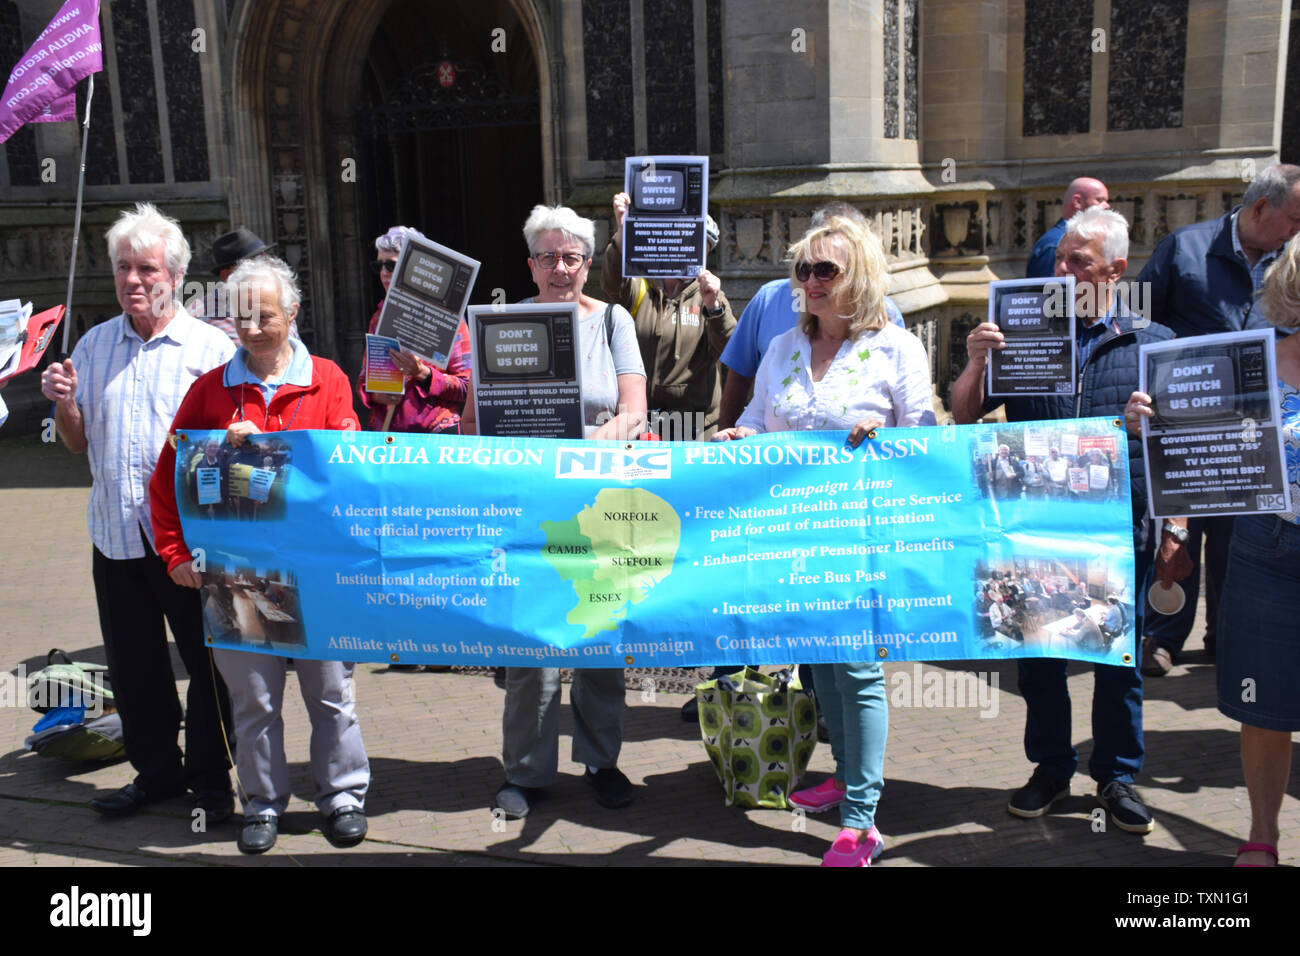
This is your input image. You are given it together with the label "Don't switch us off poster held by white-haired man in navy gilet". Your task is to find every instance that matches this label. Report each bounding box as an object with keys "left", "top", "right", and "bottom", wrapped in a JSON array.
[{"left": 985, "top": 276, "right": 1076, "bottom": 395}]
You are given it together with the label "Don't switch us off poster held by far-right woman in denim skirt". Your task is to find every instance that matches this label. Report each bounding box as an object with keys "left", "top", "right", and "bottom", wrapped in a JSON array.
[{"left": 1139, "top": 329, "right": 1291, "bottom": 518}]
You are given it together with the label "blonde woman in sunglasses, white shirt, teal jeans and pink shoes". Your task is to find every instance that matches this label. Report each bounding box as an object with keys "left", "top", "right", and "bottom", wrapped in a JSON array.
[{"left": 714, "top": 216, "right": 935, "bottom": 866}]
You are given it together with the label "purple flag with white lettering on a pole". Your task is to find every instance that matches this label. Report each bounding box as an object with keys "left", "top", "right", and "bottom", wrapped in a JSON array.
[{"left": 0, "top": 0, "right": 104, "bottom": 143}]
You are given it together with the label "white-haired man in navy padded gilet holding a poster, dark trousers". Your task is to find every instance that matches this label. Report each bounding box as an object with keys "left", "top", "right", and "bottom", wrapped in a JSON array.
[{"left": 953, "top": 208, "right": 1174, "bottom": 834}]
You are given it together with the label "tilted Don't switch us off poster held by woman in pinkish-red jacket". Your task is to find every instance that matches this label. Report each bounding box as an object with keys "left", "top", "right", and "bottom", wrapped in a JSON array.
[{"left": 374, "top": 235, "right": 478, "bottom": 369}]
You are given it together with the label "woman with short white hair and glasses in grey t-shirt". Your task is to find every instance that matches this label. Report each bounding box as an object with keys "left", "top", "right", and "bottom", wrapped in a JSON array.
[{"left": 463, "top": 206, "right": 646, "bottom": 819}]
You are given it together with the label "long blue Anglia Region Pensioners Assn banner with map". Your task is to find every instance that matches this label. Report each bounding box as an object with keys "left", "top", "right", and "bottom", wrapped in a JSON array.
[{"left": 177, "top": 419, "right": 1135, "bottom": 667}]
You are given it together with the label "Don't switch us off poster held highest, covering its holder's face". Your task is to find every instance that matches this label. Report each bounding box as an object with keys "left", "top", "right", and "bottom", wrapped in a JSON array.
[{"left": 621, "top": 156, "right": 709, "bottom": 278}]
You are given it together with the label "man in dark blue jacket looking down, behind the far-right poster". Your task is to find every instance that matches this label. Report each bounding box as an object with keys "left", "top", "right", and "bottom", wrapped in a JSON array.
[{"left": 1138, "top": 165, "right": 1300, "bottom": 676}]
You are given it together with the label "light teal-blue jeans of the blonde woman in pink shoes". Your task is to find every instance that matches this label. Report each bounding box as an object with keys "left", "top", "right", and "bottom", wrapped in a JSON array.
[{"left": 813, "top": 661, "right": 889, "bottom": 830}]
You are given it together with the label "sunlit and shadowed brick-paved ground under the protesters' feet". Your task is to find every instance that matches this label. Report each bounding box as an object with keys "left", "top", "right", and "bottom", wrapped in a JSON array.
[{"left": 0, "top": 437, "right": 1300, "bottom": 866}]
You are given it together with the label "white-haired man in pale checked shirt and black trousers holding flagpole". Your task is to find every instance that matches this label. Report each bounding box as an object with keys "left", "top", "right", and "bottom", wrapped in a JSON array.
[{"left": 40, "top": 203, "right": 234, "bottom": 823}]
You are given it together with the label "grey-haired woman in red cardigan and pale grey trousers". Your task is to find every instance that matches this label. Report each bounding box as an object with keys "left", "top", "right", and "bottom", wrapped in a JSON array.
[{"left": 150, "top": 256, "right": 371, "bottom": 853}]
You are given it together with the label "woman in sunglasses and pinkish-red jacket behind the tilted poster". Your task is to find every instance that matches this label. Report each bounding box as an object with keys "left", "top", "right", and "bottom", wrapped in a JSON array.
[{"left": 358, "top": 226, "right": 469, "bottom": 432}]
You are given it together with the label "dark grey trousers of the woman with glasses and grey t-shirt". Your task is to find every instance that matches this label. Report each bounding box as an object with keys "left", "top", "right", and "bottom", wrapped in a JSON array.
[{"left": 502, "top": 667, "right": 624, "bottom": 787}]
